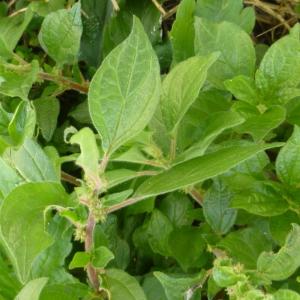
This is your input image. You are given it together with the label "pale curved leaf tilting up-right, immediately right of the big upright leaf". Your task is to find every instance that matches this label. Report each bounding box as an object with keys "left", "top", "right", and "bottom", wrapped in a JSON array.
[{"left": 160, "top": 53, "right": 218, "bottom": 133}]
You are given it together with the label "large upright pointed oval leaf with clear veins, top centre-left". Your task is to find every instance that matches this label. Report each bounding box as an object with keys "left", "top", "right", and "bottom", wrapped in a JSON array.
[{"left": 88, "top": 17, "right": 160, "bottom": 153}]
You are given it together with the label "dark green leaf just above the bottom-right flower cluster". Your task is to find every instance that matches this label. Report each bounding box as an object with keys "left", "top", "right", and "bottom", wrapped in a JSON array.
[{"left": 218, "top": 227, "right": 272, "bottom": 269}]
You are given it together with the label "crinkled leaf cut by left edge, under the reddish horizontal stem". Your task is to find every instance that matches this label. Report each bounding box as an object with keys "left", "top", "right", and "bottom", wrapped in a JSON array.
[{"left": 0, "top": 60, "right": 39, "bottom": 100}]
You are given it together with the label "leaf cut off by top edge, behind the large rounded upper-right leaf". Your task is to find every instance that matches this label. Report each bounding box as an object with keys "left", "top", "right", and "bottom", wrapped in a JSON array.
[{"left": 196, "top": 0, "right": 255, "bottom": 33}]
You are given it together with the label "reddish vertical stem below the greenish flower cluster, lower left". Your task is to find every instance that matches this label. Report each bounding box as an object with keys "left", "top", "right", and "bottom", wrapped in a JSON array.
[{"left": 84, "top": 211, "right": 99, "bottom": 291}]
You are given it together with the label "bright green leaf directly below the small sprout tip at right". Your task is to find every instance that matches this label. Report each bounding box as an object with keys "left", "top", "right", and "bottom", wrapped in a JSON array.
[{"left": 234, "top": 102, "right": 286, "bottom": 142}]
